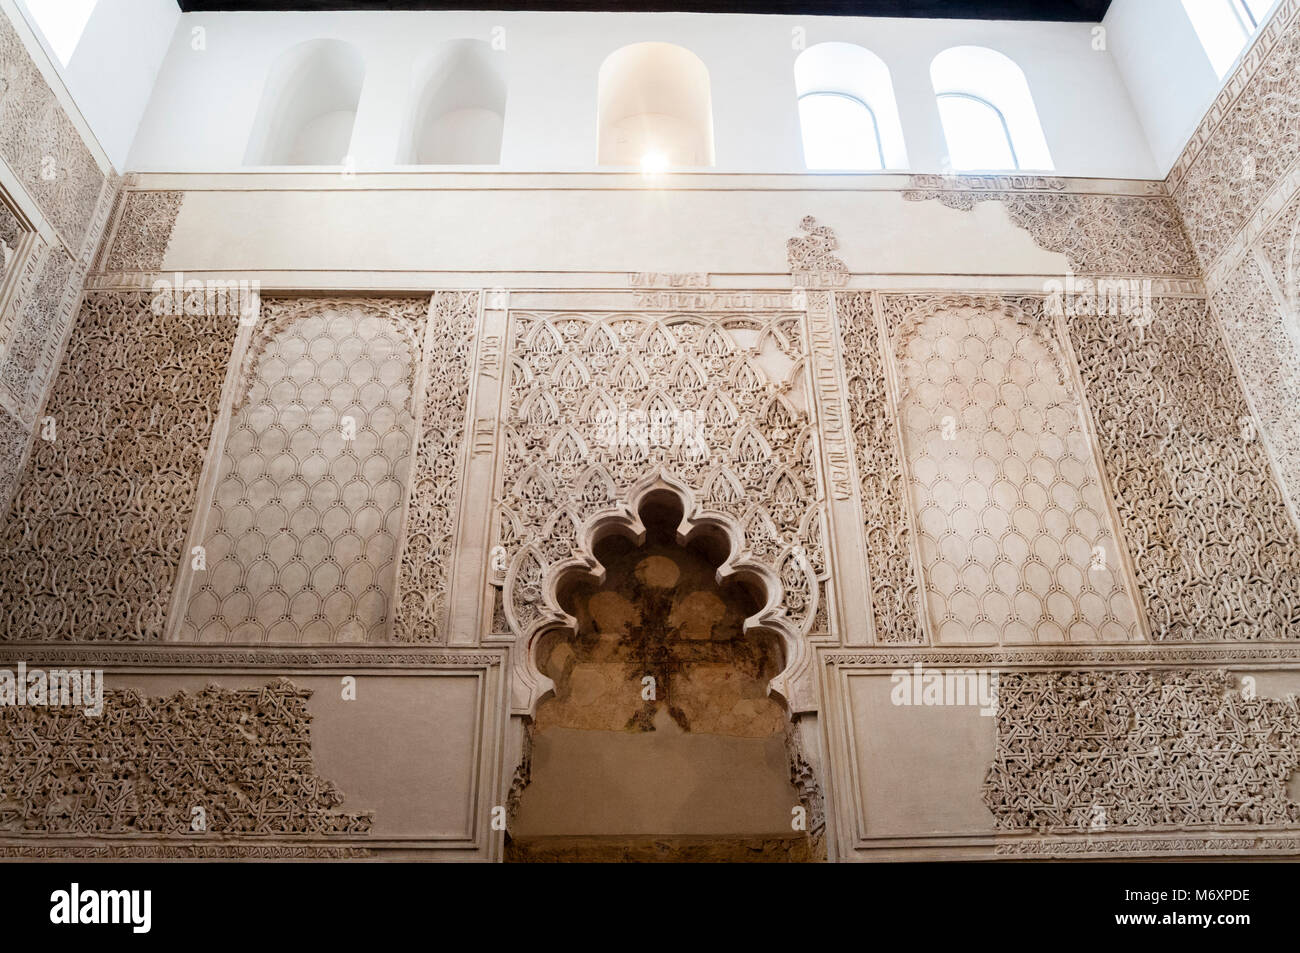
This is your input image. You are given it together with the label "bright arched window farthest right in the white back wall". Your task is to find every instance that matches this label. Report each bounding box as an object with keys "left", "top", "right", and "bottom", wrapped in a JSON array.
[{"left": 930, "top": 47, "right": 1053, "bottom": 172}]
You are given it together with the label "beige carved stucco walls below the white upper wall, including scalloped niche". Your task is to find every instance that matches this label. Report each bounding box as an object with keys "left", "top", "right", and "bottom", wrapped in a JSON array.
[{"left": 0, "top": 0, "right": 1300, "bottom": 861}]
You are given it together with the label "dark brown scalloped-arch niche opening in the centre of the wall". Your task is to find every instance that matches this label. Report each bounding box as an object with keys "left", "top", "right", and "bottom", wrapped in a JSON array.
[{"left": 506, "top": 490, "right": 819, "bottom": 861}]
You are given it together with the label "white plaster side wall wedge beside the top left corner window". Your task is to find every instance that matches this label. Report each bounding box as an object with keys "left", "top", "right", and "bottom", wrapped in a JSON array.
[{"left": 17, "top": 0, "right": 181, "bottom": 172}]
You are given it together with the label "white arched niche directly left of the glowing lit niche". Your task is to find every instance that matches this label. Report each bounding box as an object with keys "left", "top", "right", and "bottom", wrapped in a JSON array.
[{"left": 398, "top": 39, "right": 506, "bottom": 165}]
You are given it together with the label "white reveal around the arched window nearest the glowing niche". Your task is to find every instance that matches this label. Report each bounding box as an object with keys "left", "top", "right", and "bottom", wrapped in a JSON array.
[{"left": 794, "top": 43, "right": 907, "bottom": 169}]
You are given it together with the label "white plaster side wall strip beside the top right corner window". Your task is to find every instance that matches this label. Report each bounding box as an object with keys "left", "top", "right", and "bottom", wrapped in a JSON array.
[{"left": 1102, "top": 0, "right": 1231, "bottom": 176}]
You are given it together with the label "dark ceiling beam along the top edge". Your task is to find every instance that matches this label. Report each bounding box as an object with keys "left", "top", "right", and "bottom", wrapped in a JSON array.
[{"left": 179, "top": 0, "right": 1110, "bottom": 23}]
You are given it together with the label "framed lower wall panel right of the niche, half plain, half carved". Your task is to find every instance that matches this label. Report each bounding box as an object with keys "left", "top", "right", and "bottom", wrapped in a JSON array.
[{"left": 823, "top": 651, "right": 1300, "bottom": 859}]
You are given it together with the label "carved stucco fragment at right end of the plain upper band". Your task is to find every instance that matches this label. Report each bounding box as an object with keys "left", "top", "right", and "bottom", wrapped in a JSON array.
[{"left": 904, "top": 176, "right": 1200, "bottom": 278}]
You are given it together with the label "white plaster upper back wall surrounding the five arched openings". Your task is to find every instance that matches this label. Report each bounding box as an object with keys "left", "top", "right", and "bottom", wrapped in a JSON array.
[{"left": 124, "top": 9, "right": 1162, "bottom": 178}]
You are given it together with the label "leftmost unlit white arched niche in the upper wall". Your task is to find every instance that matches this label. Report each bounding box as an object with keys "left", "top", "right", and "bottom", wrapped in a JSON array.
[{"left": 244, "top": 39, "right": 365, "bottom": 165}]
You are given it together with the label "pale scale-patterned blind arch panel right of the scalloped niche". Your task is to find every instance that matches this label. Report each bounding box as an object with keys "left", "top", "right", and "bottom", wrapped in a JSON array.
[{"left": 881, "top": 295, "right": 1140, "bottom": 642}]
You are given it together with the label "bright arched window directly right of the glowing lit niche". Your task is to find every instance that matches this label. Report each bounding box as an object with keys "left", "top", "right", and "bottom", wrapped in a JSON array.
[{"left": 794, "top": 43, "right": 907, "bottom": 170}]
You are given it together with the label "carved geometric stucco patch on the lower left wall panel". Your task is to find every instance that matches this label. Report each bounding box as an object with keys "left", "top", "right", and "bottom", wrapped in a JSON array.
[{"left": 0, "top": 679, "right": 373, "bottom": 832}]
